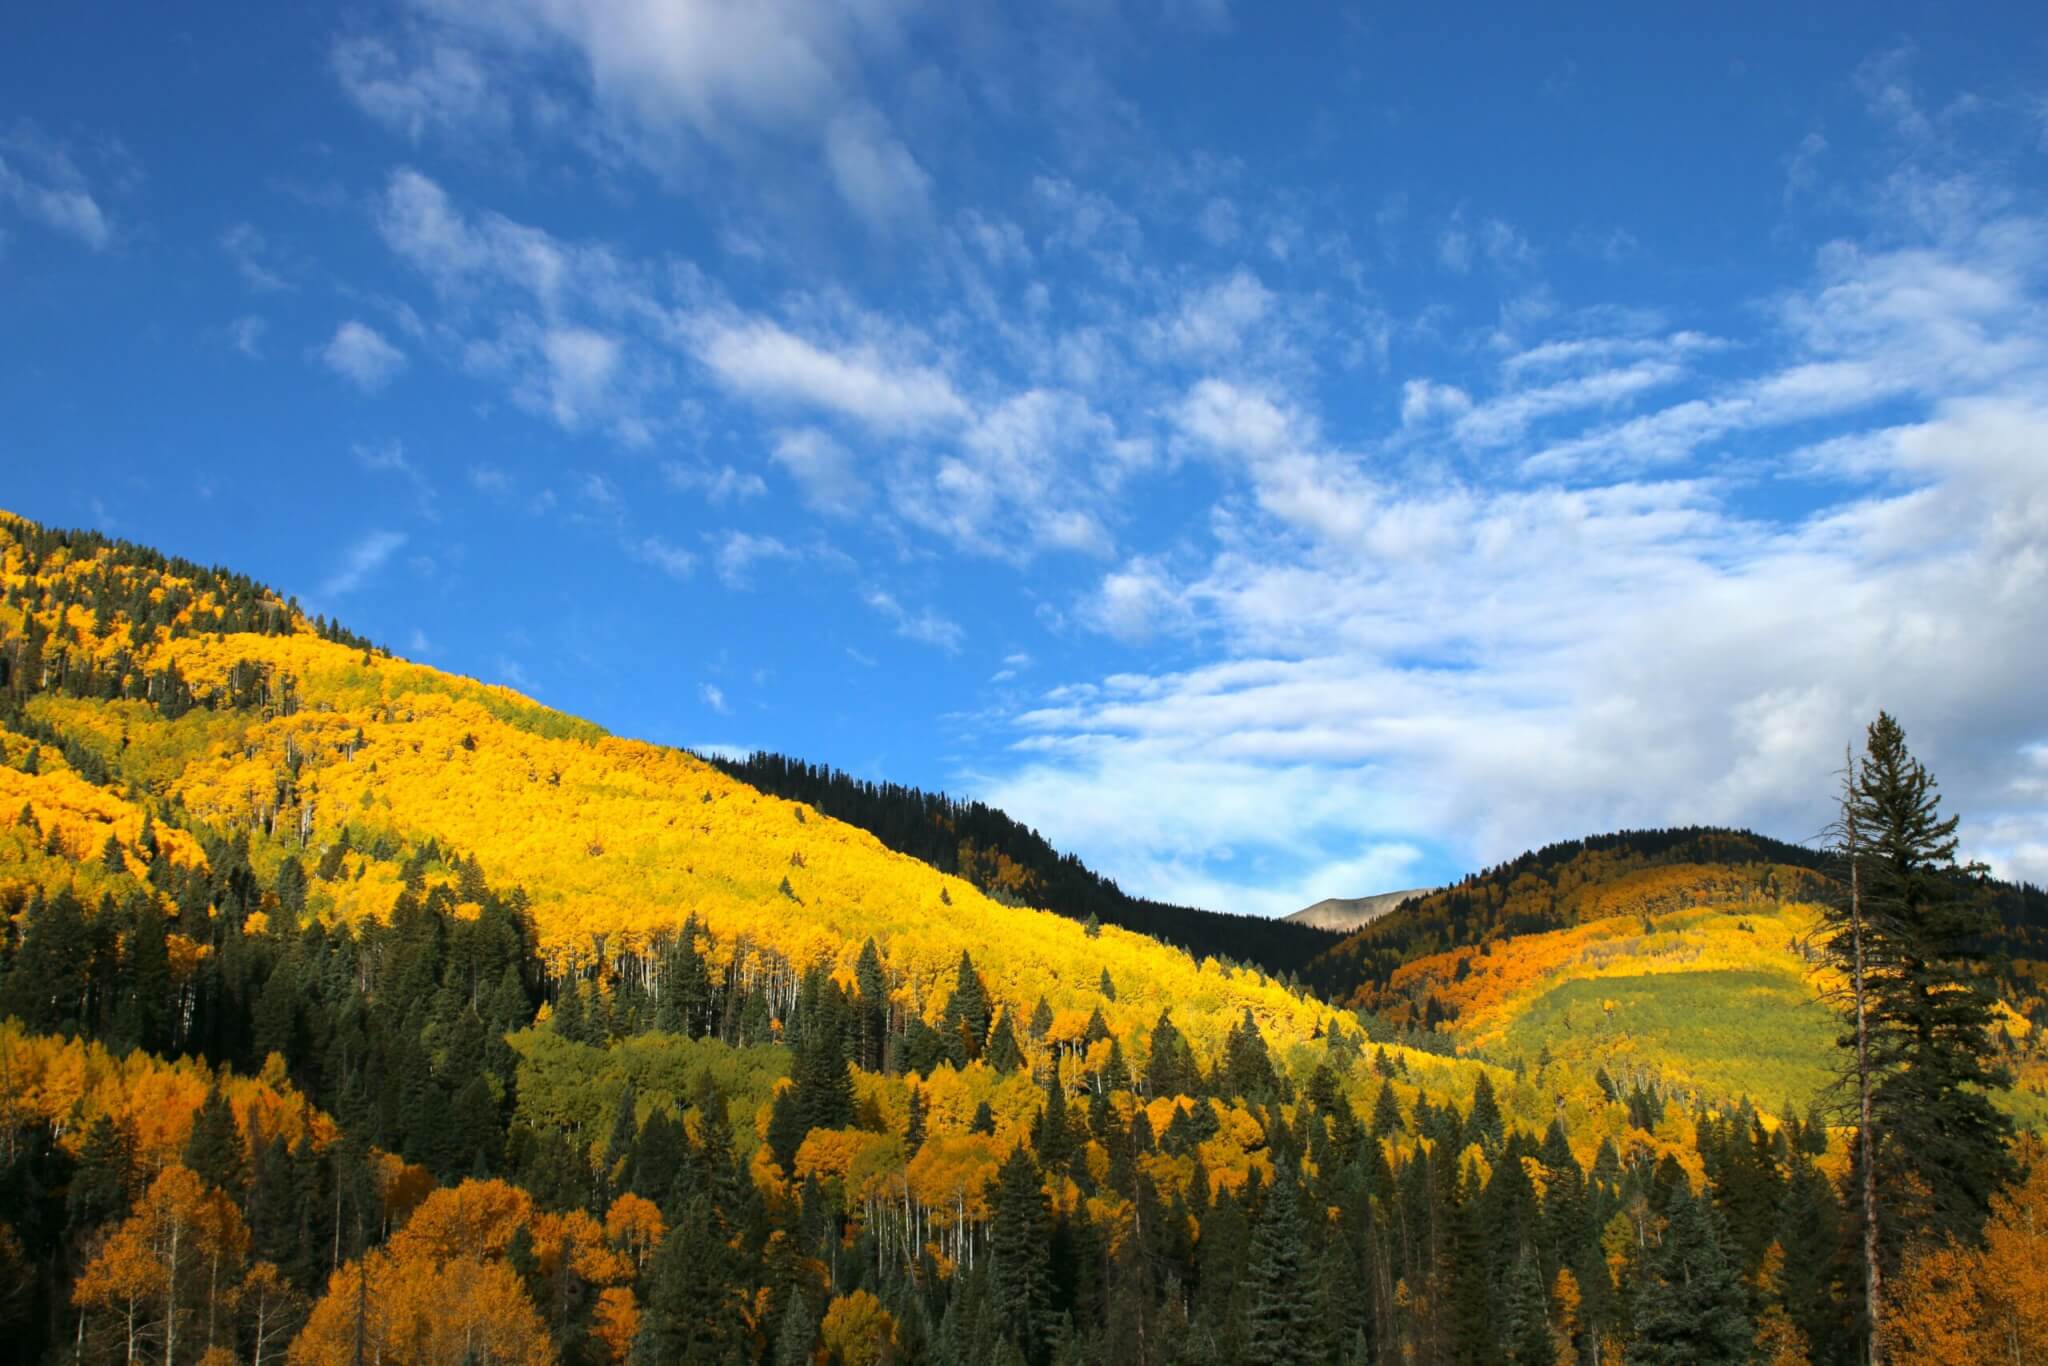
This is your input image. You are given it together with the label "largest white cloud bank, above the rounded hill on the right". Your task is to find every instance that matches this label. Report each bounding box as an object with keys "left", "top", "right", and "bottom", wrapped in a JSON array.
[{"left": 977, "top": 179, "right": 2048, "bottom": 909}]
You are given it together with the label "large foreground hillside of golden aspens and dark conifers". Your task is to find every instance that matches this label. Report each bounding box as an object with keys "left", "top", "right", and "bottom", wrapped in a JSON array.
[{"left": 0, "top": 518, "right": 2048, "bottom": 1366}]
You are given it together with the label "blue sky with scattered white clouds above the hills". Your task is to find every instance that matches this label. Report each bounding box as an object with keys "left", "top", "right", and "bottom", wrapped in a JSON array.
[{"left": 0, "top": 0, "right": 2048, "bottom": 911}]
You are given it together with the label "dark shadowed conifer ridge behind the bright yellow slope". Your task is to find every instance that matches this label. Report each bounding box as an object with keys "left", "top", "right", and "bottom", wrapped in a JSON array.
[{"left": 711, "top": 752, "right": 1337, "bottom": 977}]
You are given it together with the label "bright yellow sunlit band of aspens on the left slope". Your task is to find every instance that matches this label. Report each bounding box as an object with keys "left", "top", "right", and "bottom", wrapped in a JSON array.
[{"left": 0, "top": 511, "right": 1329, "bottom": 1055}]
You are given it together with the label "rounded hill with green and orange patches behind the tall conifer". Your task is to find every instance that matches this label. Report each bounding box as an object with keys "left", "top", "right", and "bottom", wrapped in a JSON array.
[{"left": 1309, "top": 829, "right": 2048, "bottom": 1124}]
